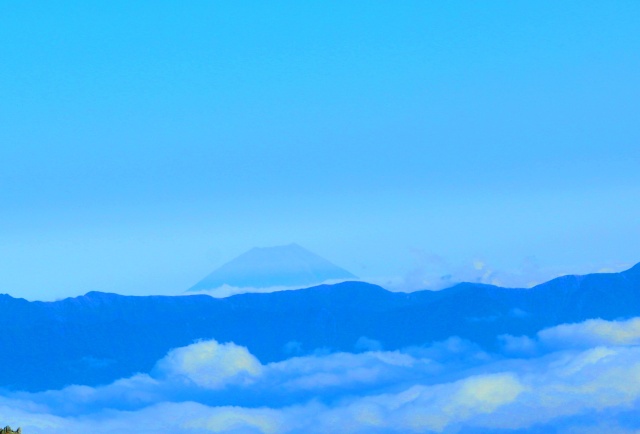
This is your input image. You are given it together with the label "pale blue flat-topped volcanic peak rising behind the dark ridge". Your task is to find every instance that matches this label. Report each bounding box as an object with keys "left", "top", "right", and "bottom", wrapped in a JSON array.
[{"left": 189, "top": 244, "right": 357, "bottom": 291}]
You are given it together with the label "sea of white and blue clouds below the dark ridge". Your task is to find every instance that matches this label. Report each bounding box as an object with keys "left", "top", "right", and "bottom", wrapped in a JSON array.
[{"left": 0, "top": 318, "right": 640, "bottom": 434}]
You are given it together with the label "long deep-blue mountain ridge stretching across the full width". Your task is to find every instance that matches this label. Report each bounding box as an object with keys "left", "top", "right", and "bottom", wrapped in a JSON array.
[{"left": 0, "top": 264, "right": 640, "bottom": 391}]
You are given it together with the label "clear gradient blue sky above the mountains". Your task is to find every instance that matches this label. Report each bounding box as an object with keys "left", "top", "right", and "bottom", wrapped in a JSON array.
[{"left": 0, "top": 1, "right": 640, "bottom": 299}]
